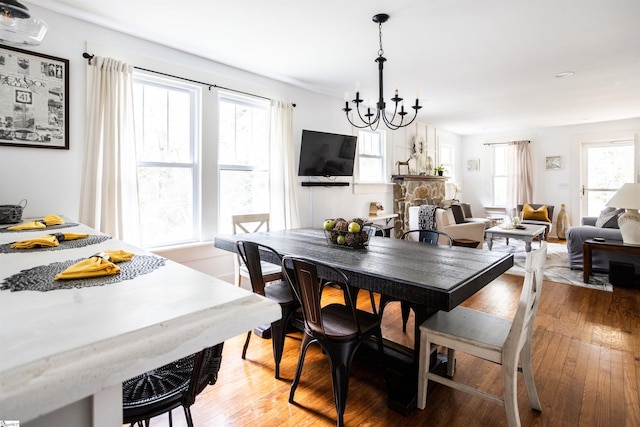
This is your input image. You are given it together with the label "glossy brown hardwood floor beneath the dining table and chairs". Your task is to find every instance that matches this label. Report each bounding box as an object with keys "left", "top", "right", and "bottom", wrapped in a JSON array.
[{"left": 130, "top": 266, "right": 640, "bottom": 427}]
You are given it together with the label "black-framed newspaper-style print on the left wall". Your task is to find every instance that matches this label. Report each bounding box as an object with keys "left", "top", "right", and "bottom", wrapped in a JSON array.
[{"left": 0, "top": 45, "right": 69, "bottom": 150}]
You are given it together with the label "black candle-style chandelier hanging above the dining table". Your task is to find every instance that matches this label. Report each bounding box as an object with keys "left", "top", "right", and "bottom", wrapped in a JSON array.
[{"left": 342, "top": 13, "right": 422, "bottom": 130}]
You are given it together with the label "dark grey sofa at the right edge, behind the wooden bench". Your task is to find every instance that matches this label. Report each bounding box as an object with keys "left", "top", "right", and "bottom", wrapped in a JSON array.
[{"left": 566, "top": 217, "right": 640, "bottom": 274}]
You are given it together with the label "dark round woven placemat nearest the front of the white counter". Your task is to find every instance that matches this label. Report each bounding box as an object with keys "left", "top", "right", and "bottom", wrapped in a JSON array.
[{"left": 0, "top": 255, "right": 166, "bottom": 292}]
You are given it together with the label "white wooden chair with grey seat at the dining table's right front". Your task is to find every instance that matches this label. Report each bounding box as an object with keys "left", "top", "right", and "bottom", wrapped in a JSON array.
[{"left": 418, "top": 242, "right": 547, "bottom": 427}]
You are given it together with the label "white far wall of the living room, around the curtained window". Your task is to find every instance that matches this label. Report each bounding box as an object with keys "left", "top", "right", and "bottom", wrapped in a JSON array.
[{"left": 461, "top": 118, "right": 640, "bottom": 234}]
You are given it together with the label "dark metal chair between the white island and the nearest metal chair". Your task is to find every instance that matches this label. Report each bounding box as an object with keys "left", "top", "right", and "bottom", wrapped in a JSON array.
[{"left": 236, "top": 240, "right": 300, "bottom": 379}]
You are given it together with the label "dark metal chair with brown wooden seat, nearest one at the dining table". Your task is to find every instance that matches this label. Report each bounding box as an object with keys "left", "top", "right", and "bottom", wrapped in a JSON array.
[{"left": 282, "top": 256, "right": 388, "bottom": 427}]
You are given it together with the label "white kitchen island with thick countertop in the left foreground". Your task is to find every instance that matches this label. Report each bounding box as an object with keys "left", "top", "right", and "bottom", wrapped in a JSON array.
[{"left": 0, "top": 224, "right": 281, "bottom": 427}]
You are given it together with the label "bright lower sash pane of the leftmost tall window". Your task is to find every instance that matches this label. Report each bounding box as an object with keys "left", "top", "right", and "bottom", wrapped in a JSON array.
[{"left": 138, "top": 167, "right": 195, "bottom": 247}]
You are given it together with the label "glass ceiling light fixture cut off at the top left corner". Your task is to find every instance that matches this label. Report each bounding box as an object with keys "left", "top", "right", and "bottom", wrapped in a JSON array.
[{"left": 0, "top": 0, "right": 47, "bottom": 46}]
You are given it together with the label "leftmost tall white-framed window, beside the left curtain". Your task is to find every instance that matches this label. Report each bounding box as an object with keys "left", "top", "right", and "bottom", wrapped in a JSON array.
[{"left": 134, "top": 73, "right": 200, "bottom": 248}]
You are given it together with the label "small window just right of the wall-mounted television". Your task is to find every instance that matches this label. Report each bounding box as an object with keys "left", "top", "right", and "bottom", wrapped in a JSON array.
[{"left": 358, "top": 130, "right": 387, "bottom": 183}]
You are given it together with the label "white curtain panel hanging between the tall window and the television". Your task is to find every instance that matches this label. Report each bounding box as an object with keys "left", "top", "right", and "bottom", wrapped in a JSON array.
[{"left": 270, "top": 100, "right": 300, "bottom": 230}]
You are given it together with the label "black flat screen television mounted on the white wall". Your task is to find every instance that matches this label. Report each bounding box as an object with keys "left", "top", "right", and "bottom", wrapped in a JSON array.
[{"left": 298, "top": 130, "right": 358, "bottom": 176}]
